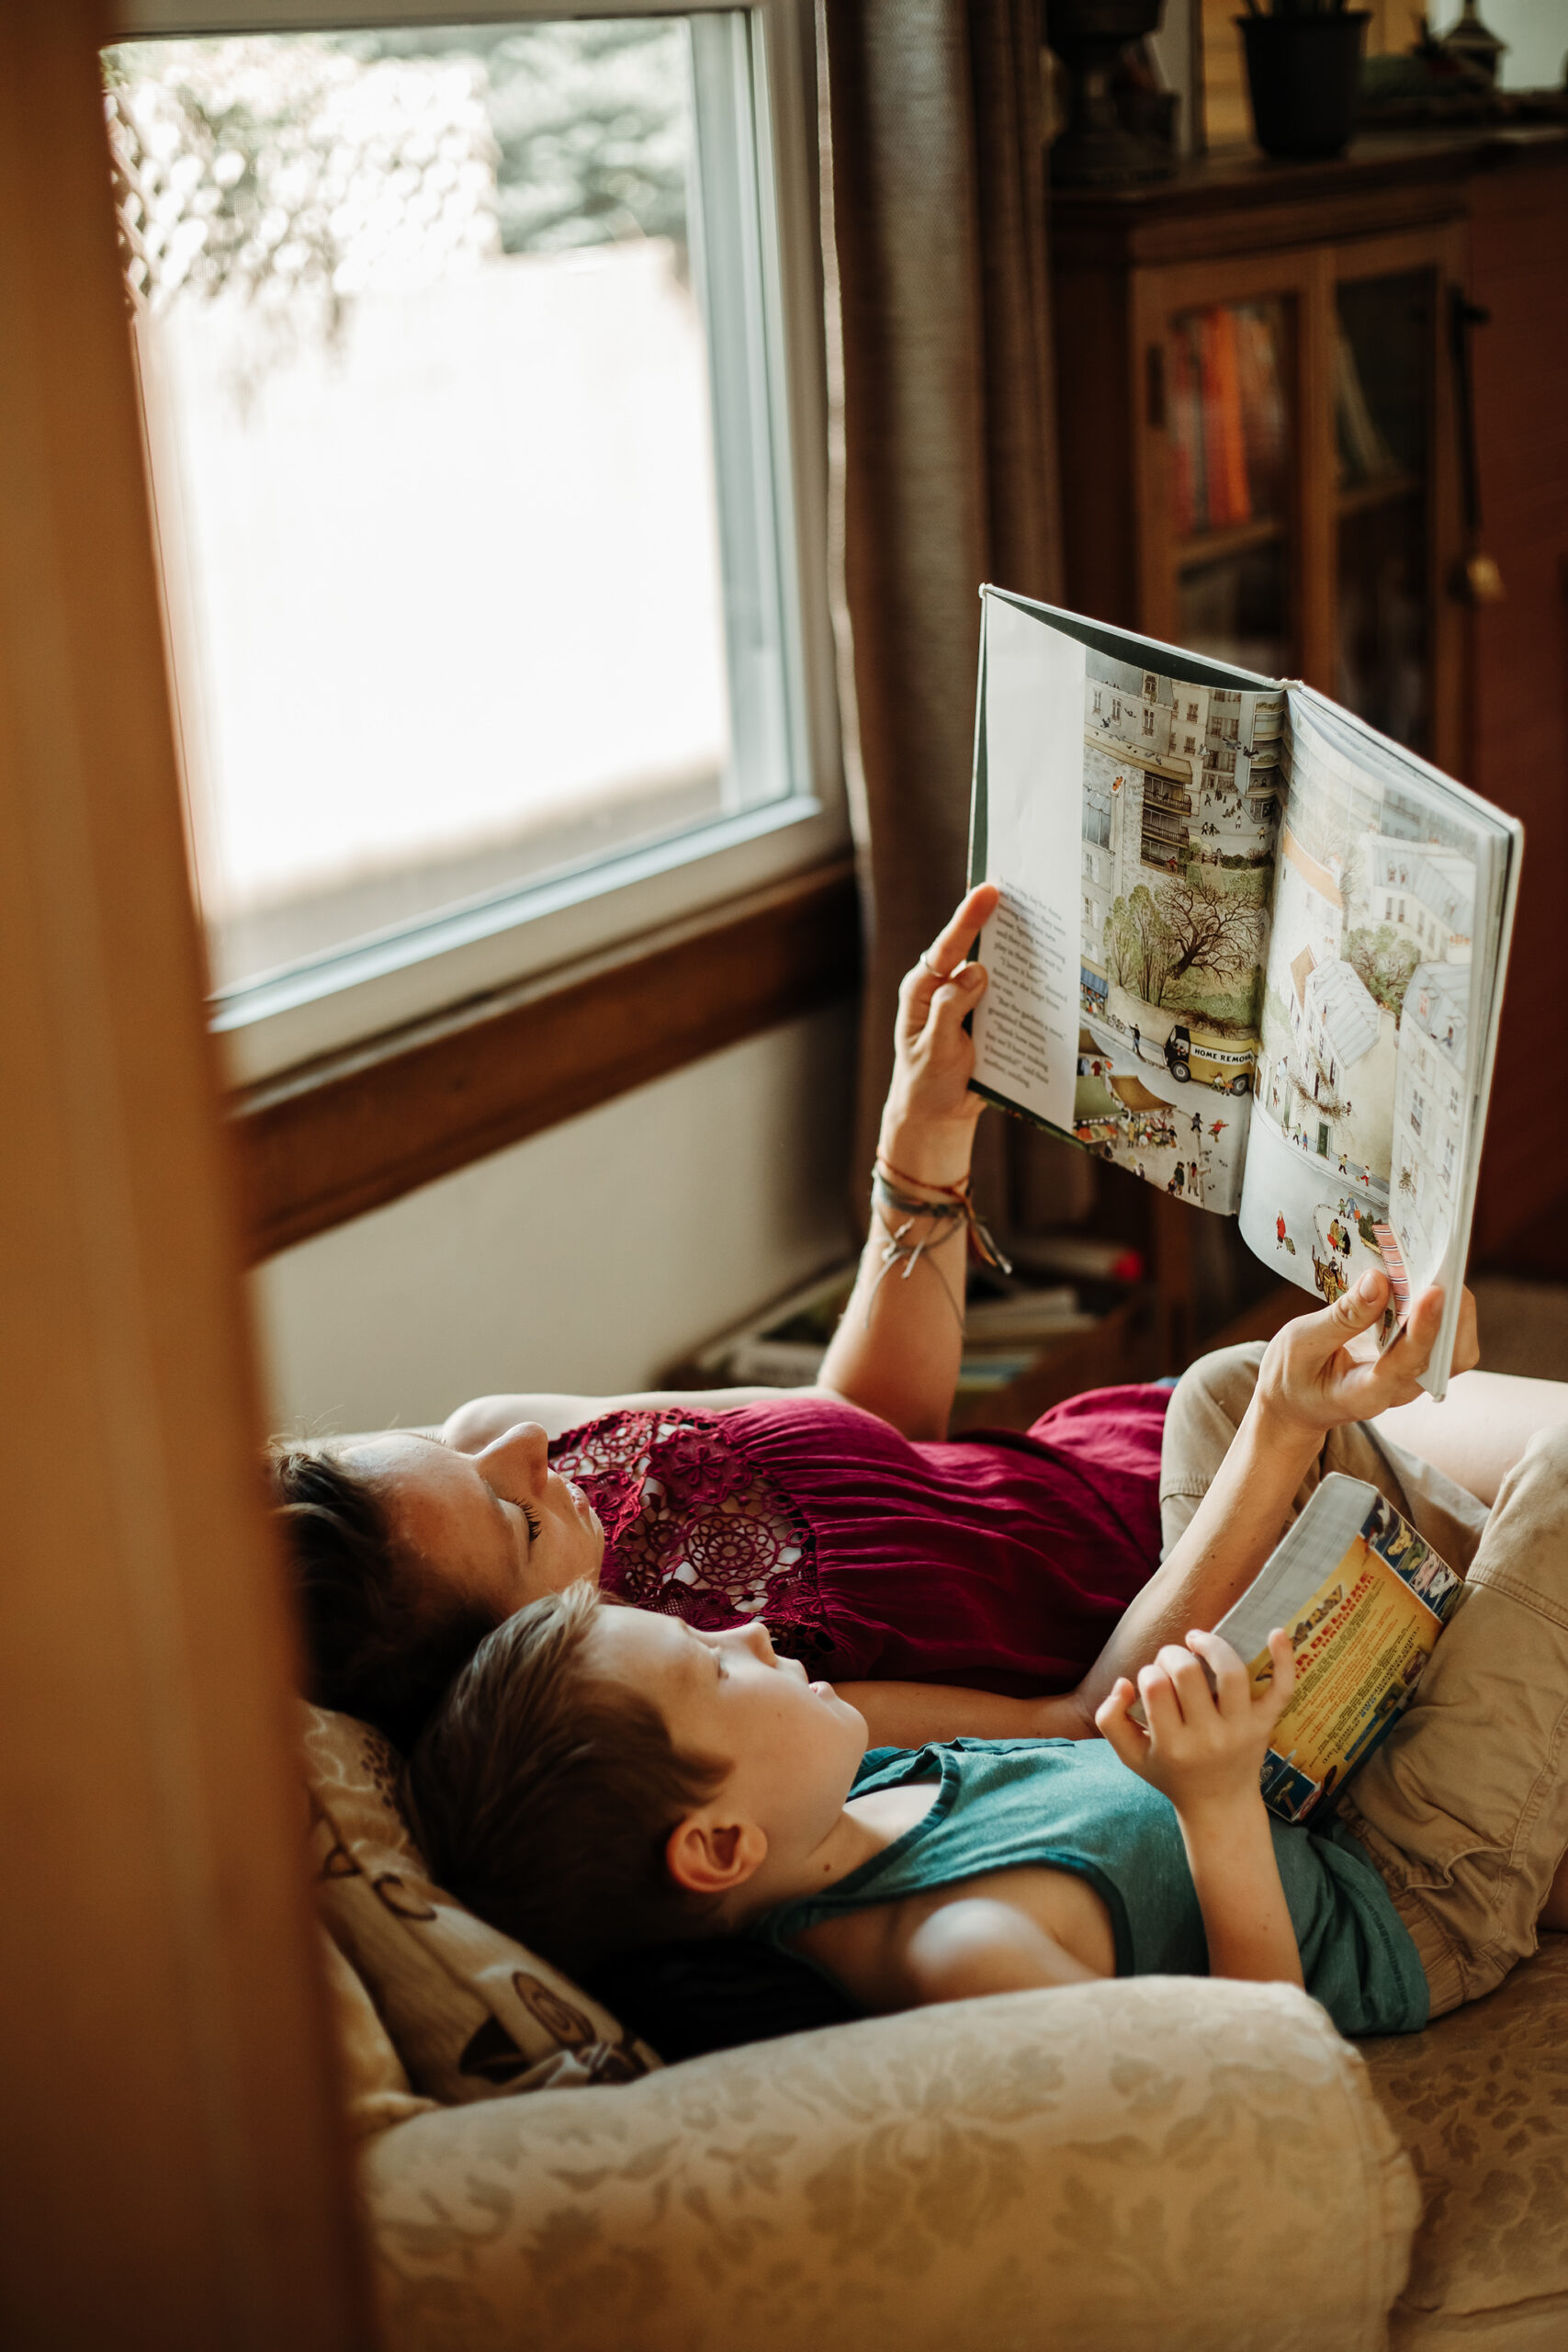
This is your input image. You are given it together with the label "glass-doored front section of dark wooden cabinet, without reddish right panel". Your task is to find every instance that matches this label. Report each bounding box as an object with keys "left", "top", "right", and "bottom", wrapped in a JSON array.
[{"left": 1054, "top": 140, "right": 1464, "bottom": 767}]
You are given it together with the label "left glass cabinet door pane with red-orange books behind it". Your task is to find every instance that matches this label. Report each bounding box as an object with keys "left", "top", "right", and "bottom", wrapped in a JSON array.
[{"left": 1166, "top": 297, "right": 1298, "bottom": 677}]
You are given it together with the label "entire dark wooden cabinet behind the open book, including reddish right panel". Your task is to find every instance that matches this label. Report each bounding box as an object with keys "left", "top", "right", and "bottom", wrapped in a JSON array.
[{"left": 1051, "top": 131, "right": 1568, "bottom": 1279}]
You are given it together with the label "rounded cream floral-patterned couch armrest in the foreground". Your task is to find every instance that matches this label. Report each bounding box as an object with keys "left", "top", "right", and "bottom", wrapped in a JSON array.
[{"left": 362, "top": 1978, "right": 1420, "bottom": 2352}]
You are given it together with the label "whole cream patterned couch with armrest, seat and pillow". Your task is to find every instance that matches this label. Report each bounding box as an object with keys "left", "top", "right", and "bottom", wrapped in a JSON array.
[{"left": 306, "top": 1710, "right": 1568, "bottom": 2352}]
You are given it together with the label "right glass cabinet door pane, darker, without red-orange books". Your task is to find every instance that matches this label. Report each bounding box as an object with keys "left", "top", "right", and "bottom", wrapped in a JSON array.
[{"left": 1333, "top": 268, "right": 1437, "bottom": 752}]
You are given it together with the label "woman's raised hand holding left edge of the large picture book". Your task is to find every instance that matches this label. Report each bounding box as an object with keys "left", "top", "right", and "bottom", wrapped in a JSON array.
[{"left": 879, "top": 882, "right": 1001, "bottom": 1185}]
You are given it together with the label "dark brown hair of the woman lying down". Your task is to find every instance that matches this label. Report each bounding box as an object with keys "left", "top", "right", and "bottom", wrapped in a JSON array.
[{"left": 268, "top": 1440, "right": 496, "bottom": 1755}]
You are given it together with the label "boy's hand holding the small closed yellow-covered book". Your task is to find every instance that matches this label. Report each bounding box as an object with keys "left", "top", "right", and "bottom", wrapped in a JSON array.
[{"left": 1096, "top": 1630, "right": 1295, "bottom": 1820}]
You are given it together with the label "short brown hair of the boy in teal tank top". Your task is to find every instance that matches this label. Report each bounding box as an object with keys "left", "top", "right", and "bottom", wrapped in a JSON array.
[{"left": 404, "top": 1583, "right": 728, "bottom": 1973}]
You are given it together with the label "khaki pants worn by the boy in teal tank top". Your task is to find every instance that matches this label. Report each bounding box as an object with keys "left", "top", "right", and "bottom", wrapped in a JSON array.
[{"left": 1159, "top": 1348, "right": 1568, "bottom": 2016}]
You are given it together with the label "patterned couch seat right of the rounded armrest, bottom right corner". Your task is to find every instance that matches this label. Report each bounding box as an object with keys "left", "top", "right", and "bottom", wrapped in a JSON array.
[{"left": 1361, "top": 1936, "right": 1568, "bottom": 2352}]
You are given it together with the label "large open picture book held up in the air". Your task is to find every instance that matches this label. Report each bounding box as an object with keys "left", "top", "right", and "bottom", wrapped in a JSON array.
[{"left": 968, "top": 588, "right": 1523, "bottom": 1397}]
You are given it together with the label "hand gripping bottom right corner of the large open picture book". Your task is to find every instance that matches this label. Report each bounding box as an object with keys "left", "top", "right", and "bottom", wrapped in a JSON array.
[{"left": 1258, "top": 1270, "right": 1479, "bottom": 1440}]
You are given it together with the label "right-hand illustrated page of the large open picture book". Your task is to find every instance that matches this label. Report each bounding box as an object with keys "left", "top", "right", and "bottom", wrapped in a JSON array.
[{"left": 1241, "top": 696, "right": 1481, "bottom": 1339}]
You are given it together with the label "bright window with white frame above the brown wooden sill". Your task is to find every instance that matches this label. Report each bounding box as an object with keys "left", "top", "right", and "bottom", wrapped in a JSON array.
[{"left": 106, "top": 0, "right": 844, "bottom": 1075}]
